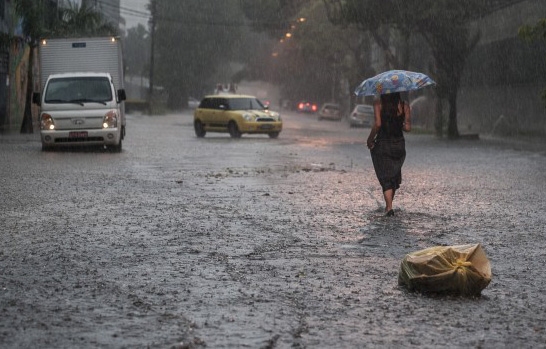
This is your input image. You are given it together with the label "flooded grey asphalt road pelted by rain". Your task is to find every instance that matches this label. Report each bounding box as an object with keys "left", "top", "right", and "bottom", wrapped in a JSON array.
[{"left": 0, "top": 113, "right": 546, "bottom": 348}]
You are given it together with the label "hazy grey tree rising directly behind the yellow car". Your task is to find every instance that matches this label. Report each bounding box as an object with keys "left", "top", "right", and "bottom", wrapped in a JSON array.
[{"left": 153, "top": 0, "right": 246, "bottom": 109}]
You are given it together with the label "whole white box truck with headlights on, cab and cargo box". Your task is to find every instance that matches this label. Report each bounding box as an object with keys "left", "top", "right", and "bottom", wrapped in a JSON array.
[{"left": 32, "top": 37, "right": 126, "bottom": 152}]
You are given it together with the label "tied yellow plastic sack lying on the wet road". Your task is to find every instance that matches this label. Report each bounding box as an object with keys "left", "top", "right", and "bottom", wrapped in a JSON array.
[{"left": 398, "top": 244, "right": 491, "bottom": 296}]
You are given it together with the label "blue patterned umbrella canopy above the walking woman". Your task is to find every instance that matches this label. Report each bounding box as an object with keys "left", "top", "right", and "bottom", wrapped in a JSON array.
[{"left": 355, "top": 70, "right": 436, "bottom": 96}]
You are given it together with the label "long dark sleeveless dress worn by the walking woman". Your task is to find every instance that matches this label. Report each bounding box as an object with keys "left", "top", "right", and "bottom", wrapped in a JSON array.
[{"left": 371, "top": 104, "right": 406, "bottom": 191}]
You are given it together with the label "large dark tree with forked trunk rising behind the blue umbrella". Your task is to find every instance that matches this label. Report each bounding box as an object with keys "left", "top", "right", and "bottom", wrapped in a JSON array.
[{"left": 324, "top": 0, "right": 488, "bottom": 139}]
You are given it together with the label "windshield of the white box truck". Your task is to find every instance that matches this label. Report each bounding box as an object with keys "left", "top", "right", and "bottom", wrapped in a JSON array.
[{"left": 45, "top": 77, "right": 112, "bottom": 104}]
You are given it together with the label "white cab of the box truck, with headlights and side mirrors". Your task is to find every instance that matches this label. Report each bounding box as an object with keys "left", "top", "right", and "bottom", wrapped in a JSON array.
[{"left": 33, "top": 72, "right": 126, "bottom": 152}]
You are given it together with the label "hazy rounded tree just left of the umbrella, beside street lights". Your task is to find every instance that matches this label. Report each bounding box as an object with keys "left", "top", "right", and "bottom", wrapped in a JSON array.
[{"left": 283, "top": 1, "right": 370, "bottom": 103}]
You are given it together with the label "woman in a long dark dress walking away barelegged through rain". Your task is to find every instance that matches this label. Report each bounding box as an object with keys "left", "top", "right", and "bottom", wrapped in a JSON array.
[{"left": 367, "top": 92, "right": 411, "bottom": 217}]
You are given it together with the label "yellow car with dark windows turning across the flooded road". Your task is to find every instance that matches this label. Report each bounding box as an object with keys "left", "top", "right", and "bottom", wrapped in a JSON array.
[{"left": 193, "top": 94, "right": 282, "bottom": 138}]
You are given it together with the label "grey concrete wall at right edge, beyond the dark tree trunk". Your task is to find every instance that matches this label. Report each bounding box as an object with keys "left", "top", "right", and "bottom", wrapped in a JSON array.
[{"left": 457, "top": 0, "right": 546, "bottom": 135}]
